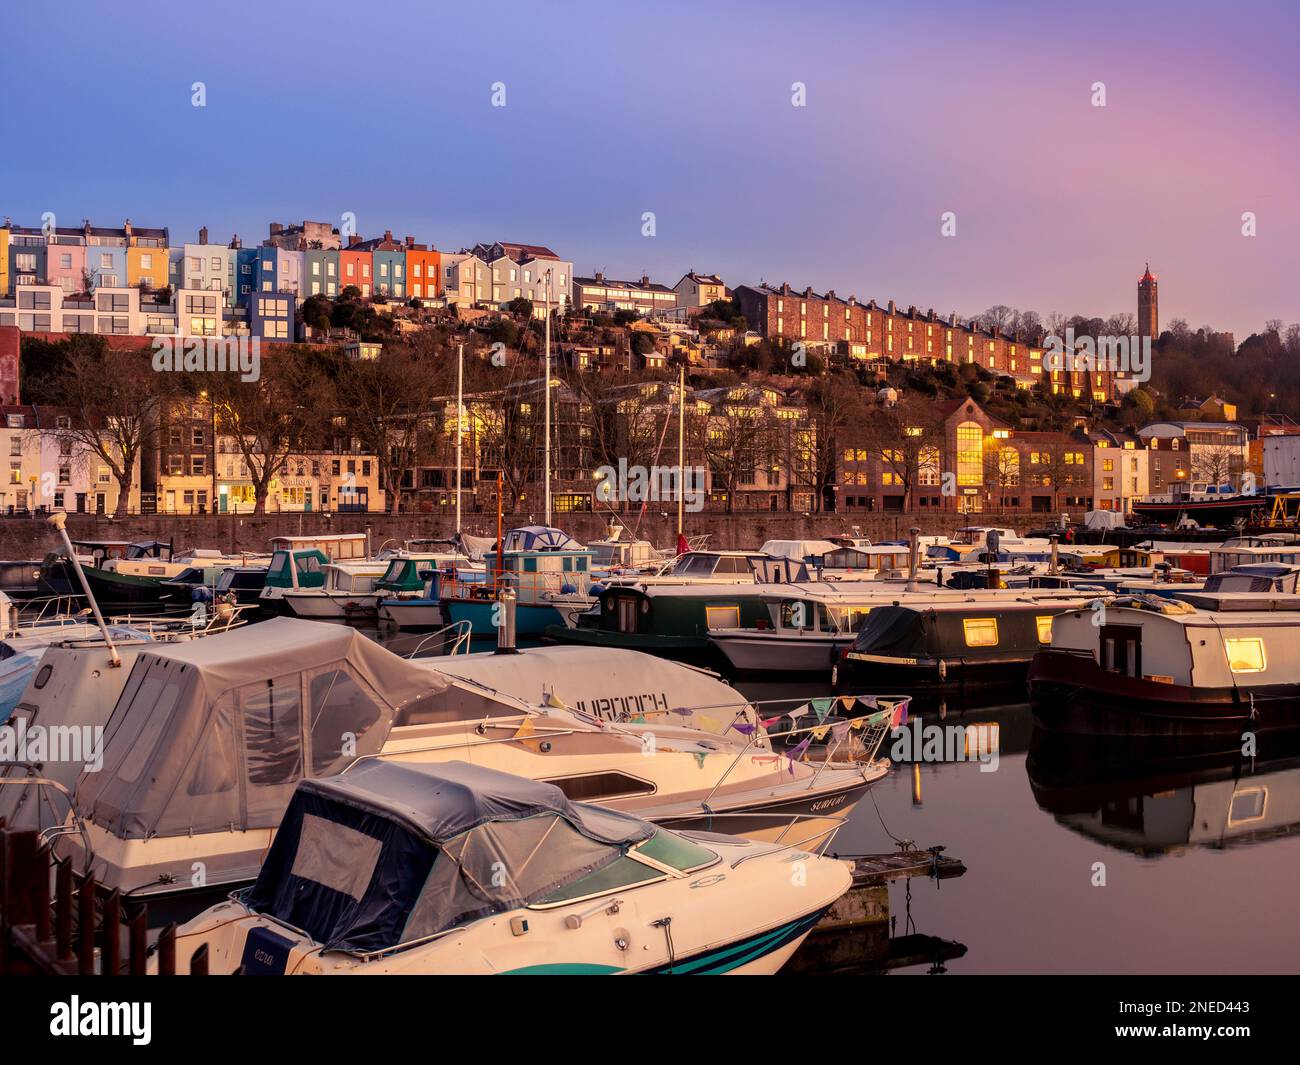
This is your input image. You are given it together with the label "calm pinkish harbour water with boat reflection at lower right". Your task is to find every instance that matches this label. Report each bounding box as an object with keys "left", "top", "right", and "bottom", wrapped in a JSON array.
[{"left": 364, "top": 636, "right": 1300, "bottom": 973}]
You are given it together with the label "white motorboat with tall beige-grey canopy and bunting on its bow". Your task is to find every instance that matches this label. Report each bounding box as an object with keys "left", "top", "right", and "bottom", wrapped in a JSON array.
[{"left": 25, "top": 618, "right": 888, "bottom": 896}]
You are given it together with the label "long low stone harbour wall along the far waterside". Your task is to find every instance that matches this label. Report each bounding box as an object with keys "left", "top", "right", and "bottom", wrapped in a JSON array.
[{"left": 0, "top": 510, "right": 1071, "bottom": 559}]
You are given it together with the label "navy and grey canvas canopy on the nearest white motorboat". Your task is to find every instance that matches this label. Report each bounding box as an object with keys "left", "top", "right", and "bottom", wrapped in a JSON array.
[{"left": 244, "top": 759, "right": 657, "bottom": 952}]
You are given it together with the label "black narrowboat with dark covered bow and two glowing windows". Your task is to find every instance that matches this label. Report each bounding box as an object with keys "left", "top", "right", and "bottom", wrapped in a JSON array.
[{"left": 832, "top": 592, "right": 1096, "bottom": 693}]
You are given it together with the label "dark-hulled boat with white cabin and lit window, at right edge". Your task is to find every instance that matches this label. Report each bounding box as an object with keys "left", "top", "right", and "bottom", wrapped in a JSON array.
[{"left": 1030, "top": 563, "right": 1300, "bottom": 736}]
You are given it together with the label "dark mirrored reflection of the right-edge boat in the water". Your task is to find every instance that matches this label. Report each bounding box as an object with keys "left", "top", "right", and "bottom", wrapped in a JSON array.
[{"left": 1027, "top": 730, "right": 1300, "bottom": 857}]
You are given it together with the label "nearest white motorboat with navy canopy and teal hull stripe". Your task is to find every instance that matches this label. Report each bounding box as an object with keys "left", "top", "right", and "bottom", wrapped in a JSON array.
[{"left": 159, "top": 759, "right": 852, "bottom": 975}]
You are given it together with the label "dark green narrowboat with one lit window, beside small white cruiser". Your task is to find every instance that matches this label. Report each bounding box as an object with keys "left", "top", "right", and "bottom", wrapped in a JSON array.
[{"left": 545, "top": 582, "right": 767, "bottom": 664}]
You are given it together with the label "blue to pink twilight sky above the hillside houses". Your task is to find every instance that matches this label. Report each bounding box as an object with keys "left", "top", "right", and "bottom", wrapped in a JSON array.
[{"left": 0, "top": 0, "right": 1300, "bottom": 341}]
